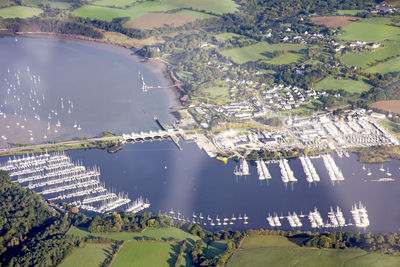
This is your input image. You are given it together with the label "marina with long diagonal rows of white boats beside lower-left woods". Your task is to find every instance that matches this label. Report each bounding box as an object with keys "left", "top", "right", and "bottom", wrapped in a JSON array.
[{"left": 0, "top": 152, "right": 150, "bottom": 213}]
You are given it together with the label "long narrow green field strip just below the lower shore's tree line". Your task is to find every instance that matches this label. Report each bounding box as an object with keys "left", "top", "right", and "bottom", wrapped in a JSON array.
[{"left": 68, "top": 227, "right": 199, "bottom": 240}]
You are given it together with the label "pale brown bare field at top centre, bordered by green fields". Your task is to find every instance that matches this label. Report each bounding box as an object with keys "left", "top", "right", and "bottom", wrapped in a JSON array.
[{"left": 124, "top": 13, "right": 196, "bottom": 30}]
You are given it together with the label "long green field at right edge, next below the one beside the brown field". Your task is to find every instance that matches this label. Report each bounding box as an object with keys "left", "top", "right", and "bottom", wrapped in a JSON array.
[{"left": 341, "top": 37, "right": 400, "bottom": 68}]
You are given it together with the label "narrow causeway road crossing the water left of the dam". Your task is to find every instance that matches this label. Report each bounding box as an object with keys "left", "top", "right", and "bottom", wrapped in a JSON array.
[{"left": 0, "top": 136, "right": 122, "bottom": 154}]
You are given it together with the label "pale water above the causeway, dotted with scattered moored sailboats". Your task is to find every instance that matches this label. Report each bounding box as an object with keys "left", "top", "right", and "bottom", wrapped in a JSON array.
[{"left": 0, "top": 37, "right": 173, "bottom": 145}]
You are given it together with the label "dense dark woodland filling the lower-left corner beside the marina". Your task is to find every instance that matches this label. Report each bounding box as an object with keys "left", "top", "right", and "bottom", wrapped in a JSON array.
[{"left": 0, "top": 171, "right": 78, "bottom": 266}]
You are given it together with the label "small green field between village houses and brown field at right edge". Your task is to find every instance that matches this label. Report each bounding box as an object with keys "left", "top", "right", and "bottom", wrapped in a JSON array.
[{"left": 313, "top": 76, "right": 371, "bottom": 93}]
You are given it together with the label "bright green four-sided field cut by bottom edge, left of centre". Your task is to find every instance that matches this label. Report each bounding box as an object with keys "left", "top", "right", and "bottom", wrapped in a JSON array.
[{"left": 111, "top": 241, "right": 179, "bottom": 267}]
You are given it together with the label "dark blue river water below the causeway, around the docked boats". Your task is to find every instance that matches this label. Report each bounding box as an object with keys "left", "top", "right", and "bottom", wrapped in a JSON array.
[{"left": 61, "top": 141, "right": 400, "bottom": 232}]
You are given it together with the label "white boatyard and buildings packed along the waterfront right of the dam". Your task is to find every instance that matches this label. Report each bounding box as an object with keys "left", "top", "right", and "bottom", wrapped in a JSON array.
[{"left": 191, "top": 109, "right": 399, "bottom": 156}]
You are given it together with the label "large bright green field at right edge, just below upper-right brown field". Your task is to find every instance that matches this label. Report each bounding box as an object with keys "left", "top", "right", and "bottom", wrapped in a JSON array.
[{"left": 340, "top": 18, "right": 400, "bottom": 42}]
